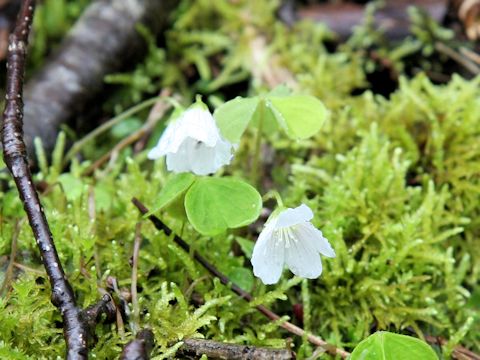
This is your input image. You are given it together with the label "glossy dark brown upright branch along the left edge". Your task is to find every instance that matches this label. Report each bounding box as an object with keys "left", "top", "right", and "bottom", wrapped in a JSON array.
[{"left": 2, "top": 0, "right": 114, "bottom": 359}]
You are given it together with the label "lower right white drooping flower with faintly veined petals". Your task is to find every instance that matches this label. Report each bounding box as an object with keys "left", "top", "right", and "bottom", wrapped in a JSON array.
[{"left": 252, "top": 204, "right": 335, "bottom": 285}]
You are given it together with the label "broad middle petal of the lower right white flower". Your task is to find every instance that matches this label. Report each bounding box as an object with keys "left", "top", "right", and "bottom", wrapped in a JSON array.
[{"left": 280, "top": 228, "right": 322, "bottom": 279}]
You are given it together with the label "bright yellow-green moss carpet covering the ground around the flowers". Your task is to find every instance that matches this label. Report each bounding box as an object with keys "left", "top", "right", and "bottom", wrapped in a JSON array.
[{"left": 0, "top": 0, "right": 480, "bottom": 359}]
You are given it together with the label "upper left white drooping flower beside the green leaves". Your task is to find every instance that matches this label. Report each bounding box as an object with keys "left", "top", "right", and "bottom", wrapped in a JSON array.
[{"left": 148, "top": 105, "right": 233, "bottom": 175}]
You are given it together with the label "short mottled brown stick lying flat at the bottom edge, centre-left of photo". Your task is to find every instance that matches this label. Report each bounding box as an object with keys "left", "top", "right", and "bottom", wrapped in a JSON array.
[{"left": 177, "top": 339, "right": 295, "bottom": 360}]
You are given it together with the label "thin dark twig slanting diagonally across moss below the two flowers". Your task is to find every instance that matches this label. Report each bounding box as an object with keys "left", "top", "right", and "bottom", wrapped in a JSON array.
[{"left": 132, "top": 198, "right": 350, "bottom": 358}]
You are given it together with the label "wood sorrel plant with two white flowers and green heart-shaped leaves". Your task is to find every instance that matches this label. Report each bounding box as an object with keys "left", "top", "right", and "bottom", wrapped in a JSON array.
[{"left": 148, "top": 87, "right": 335, "bottom": 284}]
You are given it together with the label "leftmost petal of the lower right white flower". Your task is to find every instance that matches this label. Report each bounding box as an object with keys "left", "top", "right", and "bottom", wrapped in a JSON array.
[{"left": 251, "top": 221, "right": 285, "bottom": 285}]
